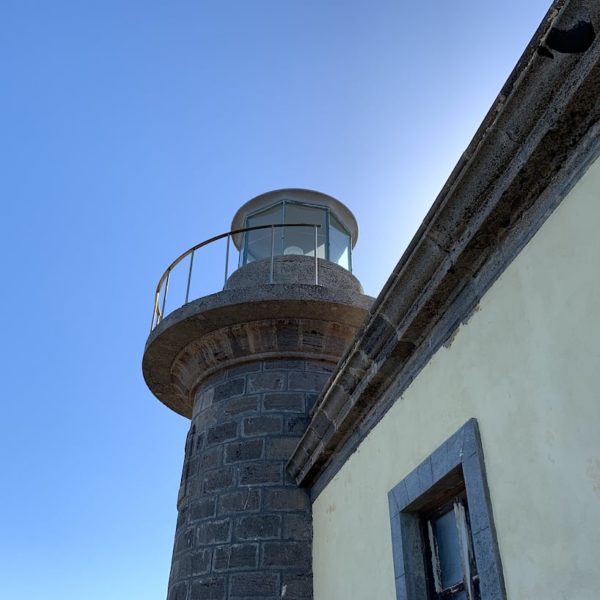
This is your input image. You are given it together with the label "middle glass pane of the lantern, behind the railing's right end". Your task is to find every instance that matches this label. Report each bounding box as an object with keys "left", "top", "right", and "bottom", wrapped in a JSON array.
[{"left": 283, "top": 202, "right": 327, "bottom": 258}]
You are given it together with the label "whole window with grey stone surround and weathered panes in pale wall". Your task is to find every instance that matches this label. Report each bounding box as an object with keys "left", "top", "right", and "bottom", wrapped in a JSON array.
[{"left": 388, "top": 419, "right": 506, "bottom": 600}]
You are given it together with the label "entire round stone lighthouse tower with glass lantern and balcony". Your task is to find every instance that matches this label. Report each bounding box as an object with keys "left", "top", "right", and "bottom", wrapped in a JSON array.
[{"left": 143, "top": 189, "right": 372, "bottom": 600}]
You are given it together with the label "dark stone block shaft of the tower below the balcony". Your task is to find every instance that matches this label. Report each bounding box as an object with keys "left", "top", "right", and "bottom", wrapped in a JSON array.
[{"left": 168, "top": 359, "right": 335, "bottom": 600}]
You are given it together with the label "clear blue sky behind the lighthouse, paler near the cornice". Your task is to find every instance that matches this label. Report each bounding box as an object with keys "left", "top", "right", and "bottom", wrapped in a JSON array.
[{"left": 0, "top": 0, "right": 549, "bottom": 600}]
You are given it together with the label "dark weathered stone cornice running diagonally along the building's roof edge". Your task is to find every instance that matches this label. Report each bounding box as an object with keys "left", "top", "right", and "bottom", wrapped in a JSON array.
[{"left": 288, "top": 0, "right": 600, "bottom": 496}]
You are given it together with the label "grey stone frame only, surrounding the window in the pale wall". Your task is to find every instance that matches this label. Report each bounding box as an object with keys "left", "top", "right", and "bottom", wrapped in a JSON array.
[{"left": 388, "top": 419, "right": 506, "bottom": 600}]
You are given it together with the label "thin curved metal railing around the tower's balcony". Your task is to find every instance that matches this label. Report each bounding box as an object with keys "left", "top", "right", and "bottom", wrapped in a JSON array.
[{"left": 150, "top": 223, "right": 321, "bottom": 331}]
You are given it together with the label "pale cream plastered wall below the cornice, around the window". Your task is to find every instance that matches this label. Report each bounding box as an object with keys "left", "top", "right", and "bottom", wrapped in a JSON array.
[{"left": 313, "top": 160, "right": 600, "bottom": 600}]
